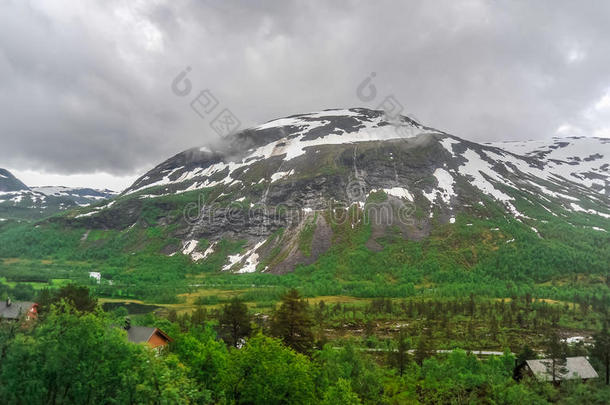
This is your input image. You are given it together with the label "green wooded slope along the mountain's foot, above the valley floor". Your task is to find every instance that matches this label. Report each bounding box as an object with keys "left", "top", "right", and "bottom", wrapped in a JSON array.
[{"left": 0, "top": 202, "right": 610, "bottom": 304}]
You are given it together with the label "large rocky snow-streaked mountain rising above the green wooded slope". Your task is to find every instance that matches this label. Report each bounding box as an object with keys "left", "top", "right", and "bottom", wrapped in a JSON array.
[{"left": 60, "top": 108, "right": 610, "bottom": 273}]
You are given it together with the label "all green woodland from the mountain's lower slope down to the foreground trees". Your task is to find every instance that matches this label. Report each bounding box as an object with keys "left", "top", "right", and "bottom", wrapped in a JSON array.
[{"left": 0, "top": 198, "right": 610, "bottom": 404}]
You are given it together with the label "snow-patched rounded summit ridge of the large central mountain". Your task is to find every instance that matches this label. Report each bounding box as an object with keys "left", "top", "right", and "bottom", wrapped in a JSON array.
[{"left": 124, "top": 108, "right": 436, "bottom": 194}]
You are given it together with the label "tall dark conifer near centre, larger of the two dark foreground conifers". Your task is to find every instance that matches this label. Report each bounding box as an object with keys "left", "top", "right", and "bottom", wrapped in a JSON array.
[{"left": 271, "top": 289, "right": 314, "bottom": 353}]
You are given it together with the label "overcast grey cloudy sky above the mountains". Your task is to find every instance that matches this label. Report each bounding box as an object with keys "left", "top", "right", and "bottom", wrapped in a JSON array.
[{"left": 0, "top": 0, "right": 610, "bottom": 189}]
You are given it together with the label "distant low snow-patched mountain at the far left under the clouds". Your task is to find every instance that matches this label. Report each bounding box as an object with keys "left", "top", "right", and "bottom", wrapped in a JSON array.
[{"left": 0, "top": 169, "right": 117, "bottom": 221}]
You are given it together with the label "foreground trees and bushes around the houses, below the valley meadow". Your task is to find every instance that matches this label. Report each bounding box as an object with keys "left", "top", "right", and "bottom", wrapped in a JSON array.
[{"left": 0, "top": 285, "right": 610, "bottom": 404}]
